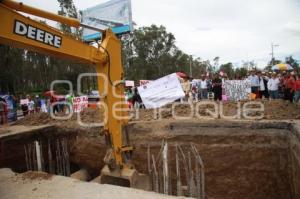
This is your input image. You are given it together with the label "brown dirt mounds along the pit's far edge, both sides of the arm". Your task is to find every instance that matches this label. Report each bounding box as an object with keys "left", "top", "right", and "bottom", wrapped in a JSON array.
[{"left": 15, "top": 100, "right": 300, "bottom": 126}]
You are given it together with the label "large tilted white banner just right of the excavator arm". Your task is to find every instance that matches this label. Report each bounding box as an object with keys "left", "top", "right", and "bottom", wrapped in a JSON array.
[{"left": 138, "top": 73, "right": 184, "bottom": 109}]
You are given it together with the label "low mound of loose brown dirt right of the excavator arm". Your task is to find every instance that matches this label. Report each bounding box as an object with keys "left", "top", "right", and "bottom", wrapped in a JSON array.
[{"left": 132, "top": 100, "right": 300, "bottom": 121}]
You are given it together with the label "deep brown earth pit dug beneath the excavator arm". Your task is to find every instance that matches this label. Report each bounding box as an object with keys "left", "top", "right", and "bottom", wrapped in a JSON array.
[{"left": 0, "top": 120, "right": 300, "bottom": 199}]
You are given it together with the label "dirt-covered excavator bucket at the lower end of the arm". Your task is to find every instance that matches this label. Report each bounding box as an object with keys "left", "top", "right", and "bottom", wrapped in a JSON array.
[{"left": 100, "top": 165, "right": 151, "bottom": 191}]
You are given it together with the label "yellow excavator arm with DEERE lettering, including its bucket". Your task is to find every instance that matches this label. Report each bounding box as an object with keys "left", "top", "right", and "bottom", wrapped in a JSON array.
[{"left": 0, "top": 0, "right": 149, "bottom": 189}]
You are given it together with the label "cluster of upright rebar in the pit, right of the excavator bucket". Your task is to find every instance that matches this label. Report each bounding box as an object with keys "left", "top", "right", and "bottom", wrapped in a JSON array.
[{"left": 147, "top": 141, "right": 205, "bottom": 199}]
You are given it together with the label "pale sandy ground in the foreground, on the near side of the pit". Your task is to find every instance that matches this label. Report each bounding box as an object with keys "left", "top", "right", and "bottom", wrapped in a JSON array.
[{"left": 0, "top": 169, "right": 185, "bottom": 199}]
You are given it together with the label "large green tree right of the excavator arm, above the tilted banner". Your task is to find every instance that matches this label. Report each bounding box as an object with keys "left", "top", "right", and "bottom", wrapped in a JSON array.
[{"left": 122, "top": 25, "right": 189, "bottom": 80}]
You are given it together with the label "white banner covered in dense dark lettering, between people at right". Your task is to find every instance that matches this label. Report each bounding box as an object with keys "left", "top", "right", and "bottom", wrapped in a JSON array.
[{"left": 224, "top": 80, "right": 251, "bottom": 101}]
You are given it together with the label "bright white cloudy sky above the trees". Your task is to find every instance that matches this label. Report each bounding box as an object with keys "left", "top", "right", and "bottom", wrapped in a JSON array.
[{"left": 18, "top": 0, "right": 300, "bottom": 68}]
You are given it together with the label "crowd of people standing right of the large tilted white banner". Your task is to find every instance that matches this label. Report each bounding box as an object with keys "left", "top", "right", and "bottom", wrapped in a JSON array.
[{"left": 181, "top": 70, "right": 300, "bottom": 103}]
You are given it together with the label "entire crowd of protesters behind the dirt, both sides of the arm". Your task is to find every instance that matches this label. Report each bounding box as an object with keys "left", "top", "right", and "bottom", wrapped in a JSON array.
[{"left": 0, "top": 70, "right": 300, "bottom": 124}]
